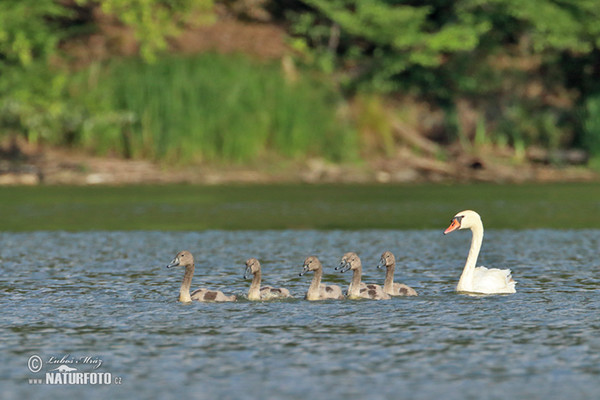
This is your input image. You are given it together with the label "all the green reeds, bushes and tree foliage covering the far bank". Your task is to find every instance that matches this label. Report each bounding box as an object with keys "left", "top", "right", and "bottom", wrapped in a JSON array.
[{"left": 0, "top": 0, "right": 600, "bottom": 161}]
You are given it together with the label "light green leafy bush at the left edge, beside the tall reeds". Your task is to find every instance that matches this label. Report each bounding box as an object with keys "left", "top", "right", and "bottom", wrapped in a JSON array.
[{"left": 0, "top": 0, "right": 77, "bottom": 142}]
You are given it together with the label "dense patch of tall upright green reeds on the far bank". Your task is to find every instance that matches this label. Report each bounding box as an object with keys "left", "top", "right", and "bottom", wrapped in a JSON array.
[{"left": 78, "top": 54, "right": 358, "bottom": 162}]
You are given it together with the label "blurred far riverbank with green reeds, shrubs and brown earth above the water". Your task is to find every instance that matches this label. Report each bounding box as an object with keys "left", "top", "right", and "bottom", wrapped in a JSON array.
[{"left": 0, "top": 0, "right": 600, "bottom": 185}]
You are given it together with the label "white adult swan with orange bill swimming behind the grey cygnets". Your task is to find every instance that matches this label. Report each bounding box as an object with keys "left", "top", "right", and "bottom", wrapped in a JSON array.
[{"left": 444, "top": 210, "right": 517, "bottom": 294}]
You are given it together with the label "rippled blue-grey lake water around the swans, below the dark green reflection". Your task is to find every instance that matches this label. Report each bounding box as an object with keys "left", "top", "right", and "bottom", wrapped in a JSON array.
[{"left": 0, "top": 226, "right": 600, "bottom": 400}]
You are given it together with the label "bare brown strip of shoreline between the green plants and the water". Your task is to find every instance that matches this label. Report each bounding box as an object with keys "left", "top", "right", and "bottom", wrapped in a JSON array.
[{"left": 0, "top": 143, "right": 600, "bottom": 185}]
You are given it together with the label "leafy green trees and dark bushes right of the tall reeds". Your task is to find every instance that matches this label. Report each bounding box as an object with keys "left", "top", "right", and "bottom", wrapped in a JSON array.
[{"left": 293, "top": 0, "right": 600, "bottom": 154}]
